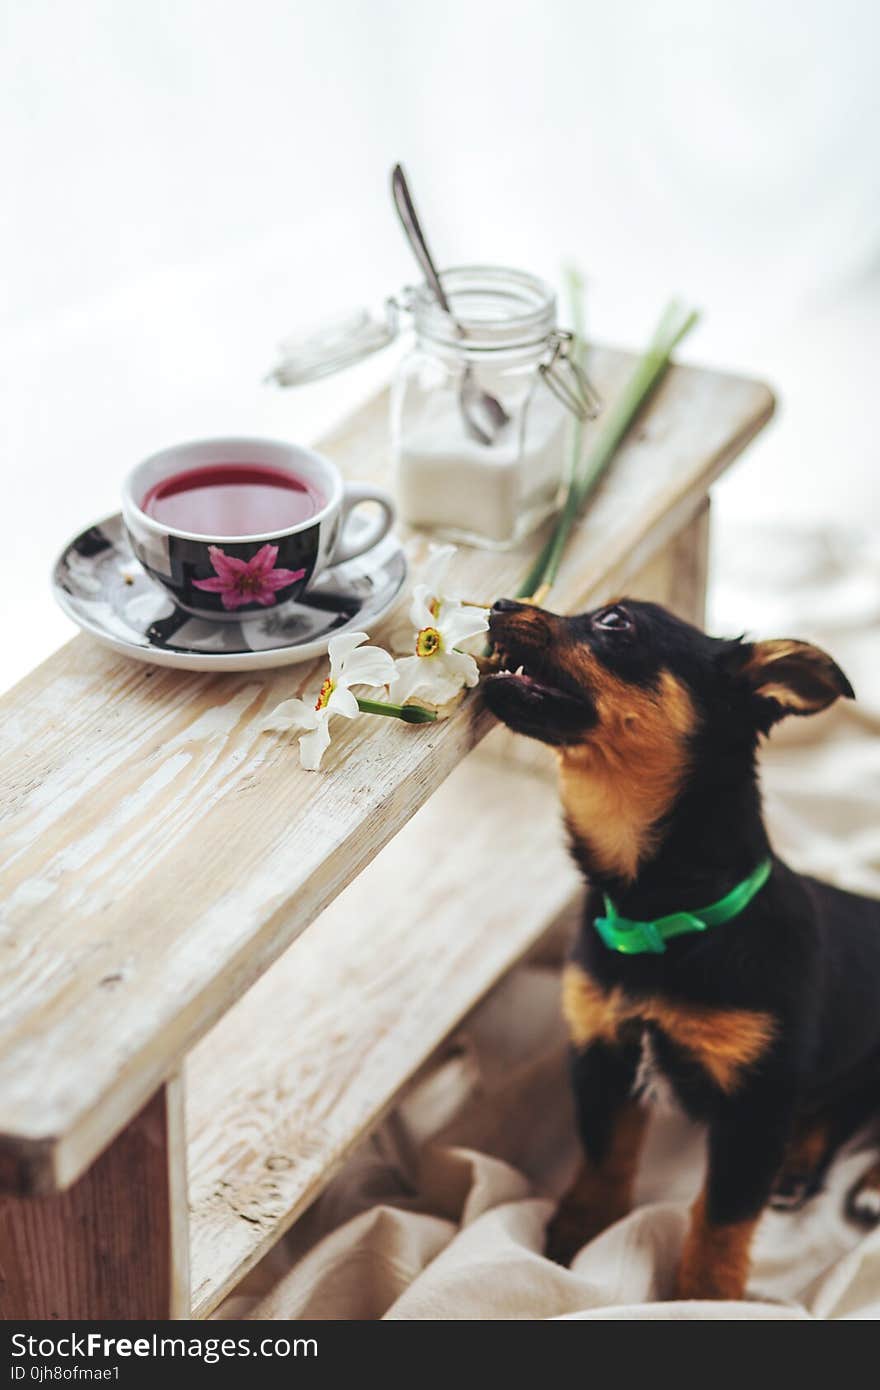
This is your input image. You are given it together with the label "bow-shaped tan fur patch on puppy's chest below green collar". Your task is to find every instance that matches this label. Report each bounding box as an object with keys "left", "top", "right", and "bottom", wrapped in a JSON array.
[{"left": 563, "top": 965, "right": 776, "bottom": 1093}]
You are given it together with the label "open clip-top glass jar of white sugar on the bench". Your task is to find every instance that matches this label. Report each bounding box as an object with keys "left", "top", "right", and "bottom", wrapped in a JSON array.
[{"left": 268, "top": 265, "right": 598, "bottom": 549}]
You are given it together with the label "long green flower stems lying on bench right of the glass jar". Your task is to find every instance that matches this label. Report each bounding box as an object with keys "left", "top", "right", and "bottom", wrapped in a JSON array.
[{"left": 516, "top": 296, "right": 699, "bottom": 598}]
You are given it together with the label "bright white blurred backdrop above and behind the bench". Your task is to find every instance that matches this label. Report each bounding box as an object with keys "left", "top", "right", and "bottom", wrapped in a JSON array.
[{"left": 0, "top": 0, "right": 880, "bottom": 684}]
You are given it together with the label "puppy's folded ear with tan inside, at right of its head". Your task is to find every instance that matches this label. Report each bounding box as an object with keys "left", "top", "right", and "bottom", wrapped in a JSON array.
[{"left": 723, "top": 638, "right": 855, "bottom": 728}]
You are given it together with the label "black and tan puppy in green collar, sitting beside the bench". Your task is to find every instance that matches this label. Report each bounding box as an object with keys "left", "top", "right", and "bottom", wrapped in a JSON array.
[{"left": 485, "top": 599, "right": 880, "bottom": 1298}]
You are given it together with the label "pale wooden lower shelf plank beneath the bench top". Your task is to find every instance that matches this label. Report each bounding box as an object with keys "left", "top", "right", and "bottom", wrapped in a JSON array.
[{"left": 186, "top": 752, "right": 581, "bottom": 1316}]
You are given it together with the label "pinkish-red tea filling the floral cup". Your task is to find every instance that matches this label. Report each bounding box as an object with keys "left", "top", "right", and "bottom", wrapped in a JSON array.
[{"left": 140, "top": 463, "right": 324, "bottom": 538}]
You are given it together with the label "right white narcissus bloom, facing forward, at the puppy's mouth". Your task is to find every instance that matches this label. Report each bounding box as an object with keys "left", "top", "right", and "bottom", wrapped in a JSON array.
[{"left": 388, "top": 584, "right": 489, "bottom": 705}]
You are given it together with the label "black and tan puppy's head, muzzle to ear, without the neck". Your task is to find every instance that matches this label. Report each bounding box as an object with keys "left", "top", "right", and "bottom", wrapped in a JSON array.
[{"left": 485, "top": 599, "right": 852, "bottom": 758}]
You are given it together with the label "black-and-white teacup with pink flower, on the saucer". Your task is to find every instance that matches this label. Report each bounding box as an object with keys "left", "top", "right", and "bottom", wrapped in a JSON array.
[{"left": 122, "top": 438, "right": 395, "bottom": 623}]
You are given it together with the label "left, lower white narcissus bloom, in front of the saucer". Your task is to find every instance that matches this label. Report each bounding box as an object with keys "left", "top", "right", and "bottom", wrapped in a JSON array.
[{"left": 263, "top": 632, "right": 395, "bottom": 771}]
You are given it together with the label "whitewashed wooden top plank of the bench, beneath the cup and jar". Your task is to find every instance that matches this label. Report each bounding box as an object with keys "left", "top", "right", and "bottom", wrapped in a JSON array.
[{"left": 0, "top": 352, "right": 773, "bottom": 1191}]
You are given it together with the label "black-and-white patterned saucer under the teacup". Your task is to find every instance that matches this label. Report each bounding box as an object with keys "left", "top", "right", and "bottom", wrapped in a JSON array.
[{"left": 51, "top": 512, "right": 406, "bottom": 671}]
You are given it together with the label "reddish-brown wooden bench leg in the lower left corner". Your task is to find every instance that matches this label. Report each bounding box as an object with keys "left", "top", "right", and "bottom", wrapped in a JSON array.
[{"left": 0, "top": 1077, "right": 189, "bottom": 1322}]
